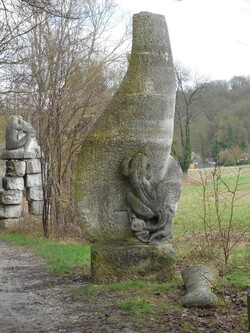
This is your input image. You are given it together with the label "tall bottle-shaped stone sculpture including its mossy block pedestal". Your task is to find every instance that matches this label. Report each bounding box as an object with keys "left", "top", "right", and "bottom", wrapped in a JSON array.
[{"left": 75, "top": 12, "right": 181, "bottom": 283}]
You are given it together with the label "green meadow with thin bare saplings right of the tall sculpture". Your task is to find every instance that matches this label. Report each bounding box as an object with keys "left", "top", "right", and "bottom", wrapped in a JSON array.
[{"left": 174, "top": 166, "right": 250, "bottom": 274}]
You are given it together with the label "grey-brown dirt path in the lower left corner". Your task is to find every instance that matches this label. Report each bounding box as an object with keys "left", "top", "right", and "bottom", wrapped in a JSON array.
[{"left": 0, "top": 241, "right": 135, "bottom": 333}]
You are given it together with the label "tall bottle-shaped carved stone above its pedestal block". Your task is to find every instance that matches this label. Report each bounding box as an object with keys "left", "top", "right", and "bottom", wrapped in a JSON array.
[{"left": 75, "top": 12, "right": 180, "bottom": 242}]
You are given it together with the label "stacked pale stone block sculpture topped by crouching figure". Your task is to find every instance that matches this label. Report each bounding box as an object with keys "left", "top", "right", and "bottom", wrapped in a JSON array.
[{"left": 0, "top": 116, "right": 43, "bottom": 223}]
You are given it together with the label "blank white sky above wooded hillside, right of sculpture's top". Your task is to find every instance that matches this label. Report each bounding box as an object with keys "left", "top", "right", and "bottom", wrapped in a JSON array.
[{"left": 118, "top": 0, "right": 250, "bottom": 80}]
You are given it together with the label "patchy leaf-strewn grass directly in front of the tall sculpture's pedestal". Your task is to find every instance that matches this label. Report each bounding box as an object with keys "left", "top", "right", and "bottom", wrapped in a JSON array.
[{"left": 68, "top": 279, "right": 182, "bottom": 322}]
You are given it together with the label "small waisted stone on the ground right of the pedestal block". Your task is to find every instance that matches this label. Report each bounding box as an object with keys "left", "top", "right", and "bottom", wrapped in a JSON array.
[{"left": 181, "top": 265, "right": 219, "bottom": 308}]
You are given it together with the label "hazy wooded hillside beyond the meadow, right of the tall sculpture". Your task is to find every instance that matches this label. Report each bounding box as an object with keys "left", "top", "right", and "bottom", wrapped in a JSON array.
[{"left": 173, "top": 66, "right": 250, "bottom": 172}]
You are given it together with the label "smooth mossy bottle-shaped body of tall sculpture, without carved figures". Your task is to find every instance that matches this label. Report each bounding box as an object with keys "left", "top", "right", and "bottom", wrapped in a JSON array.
[{"left": 75, "top": 13, "right": 175, "bottom": 241}]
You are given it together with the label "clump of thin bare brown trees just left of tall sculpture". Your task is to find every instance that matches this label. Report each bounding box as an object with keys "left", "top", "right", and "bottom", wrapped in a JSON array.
[{"left": 5, "top": 0, "right": 128, "bottom": 236}]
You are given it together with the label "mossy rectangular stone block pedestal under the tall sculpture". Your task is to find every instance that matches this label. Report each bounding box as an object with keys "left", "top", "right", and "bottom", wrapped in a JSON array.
[{"left": 91, "top": 243, "right": 176, "bottom": 284}]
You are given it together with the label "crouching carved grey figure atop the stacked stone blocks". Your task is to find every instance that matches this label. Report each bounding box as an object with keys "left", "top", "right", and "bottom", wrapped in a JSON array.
[{"left": 6, "top": 116, "right": 36, "bottom": 151}]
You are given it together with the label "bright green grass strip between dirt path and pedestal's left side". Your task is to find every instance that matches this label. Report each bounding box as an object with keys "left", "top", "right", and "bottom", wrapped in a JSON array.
[{"left": 0, "top": 232, "right": 90, "bottom": 276}]
